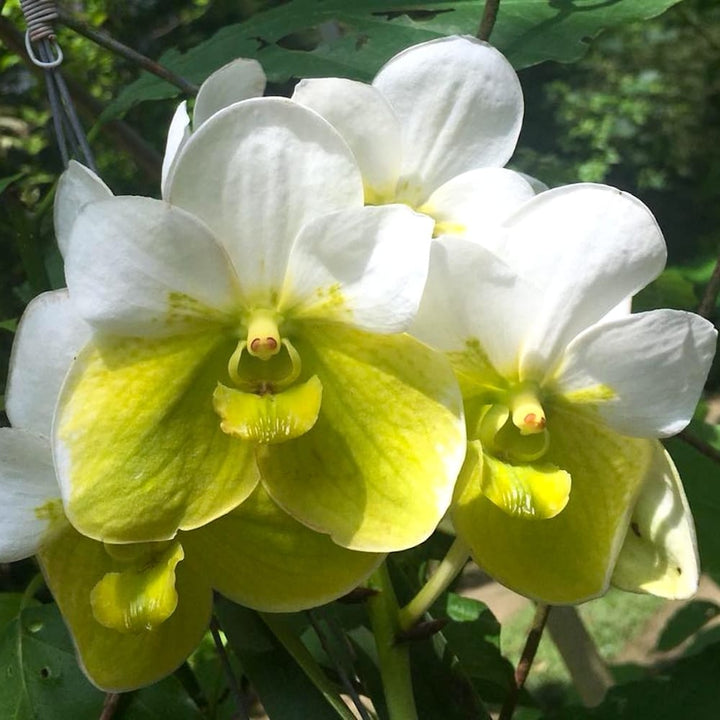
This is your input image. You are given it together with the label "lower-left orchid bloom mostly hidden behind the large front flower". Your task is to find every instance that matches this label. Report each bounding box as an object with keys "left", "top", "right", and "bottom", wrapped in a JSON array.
[{"left": 0, "top": 290, "right": 382, "bottom": 692}]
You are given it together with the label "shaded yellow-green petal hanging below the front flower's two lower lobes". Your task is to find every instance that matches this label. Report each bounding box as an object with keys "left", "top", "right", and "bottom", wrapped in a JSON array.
[{"left": 182, "top": 486, "right": 383, "bottom": 612}]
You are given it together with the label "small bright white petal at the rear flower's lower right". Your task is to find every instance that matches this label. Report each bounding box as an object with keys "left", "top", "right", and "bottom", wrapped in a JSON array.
[{"left": 419, "top": 168, "right": 535, "bottom": 244}]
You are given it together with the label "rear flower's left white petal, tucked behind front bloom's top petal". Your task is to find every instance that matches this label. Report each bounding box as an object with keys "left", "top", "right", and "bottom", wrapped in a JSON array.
[{"left": 292, "top": 78, "right": 402, "bottom": 203}]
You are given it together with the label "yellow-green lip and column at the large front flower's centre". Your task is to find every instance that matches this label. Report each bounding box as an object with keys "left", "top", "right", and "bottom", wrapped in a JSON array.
[{"left": 208, "top": 309, "right": 322, "bottom": 444}]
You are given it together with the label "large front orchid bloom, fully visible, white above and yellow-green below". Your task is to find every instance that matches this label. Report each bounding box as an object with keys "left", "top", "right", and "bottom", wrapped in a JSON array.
[{"left": 53, "top": 98, "right": 465, "bottom": 552}]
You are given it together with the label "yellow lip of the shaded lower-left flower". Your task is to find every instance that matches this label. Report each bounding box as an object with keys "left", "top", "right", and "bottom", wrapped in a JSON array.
[{"left": 90, "top": 540, "right": 185, "bottom": 633}]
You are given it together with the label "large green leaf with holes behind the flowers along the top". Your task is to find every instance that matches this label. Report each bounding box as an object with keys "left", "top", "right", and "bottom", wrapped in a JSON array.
[{"left": 102, "top": 0, "right": 678, "bottom": 120}]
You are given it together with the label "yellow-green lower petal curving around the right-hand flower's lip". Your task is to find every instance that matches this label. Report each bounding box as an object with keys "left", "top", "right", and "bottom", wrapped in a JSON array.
[{"left": 452, "top": 406, "right": 652, "bottom": 604}]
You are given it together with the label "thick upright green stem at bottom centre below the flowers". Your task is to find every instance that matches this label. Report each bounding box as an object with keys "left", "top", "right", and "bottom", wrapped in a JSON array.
[{"left": 367, "top": 563, "right": 418, "bottom": 720}]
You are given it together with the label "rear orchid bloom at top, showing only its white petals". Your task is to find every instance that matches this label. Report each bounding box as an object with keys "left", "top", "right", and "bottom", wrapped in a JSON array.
[{"left": 293, "top": 36, "right": 536, "bottom": 238}]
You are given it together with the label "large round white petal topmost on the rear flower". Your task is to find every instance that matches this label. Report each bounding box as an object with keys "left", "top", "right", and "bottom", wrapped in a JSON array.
[{"left": 373, "top": 37, "right": 523, "bottom": 200}]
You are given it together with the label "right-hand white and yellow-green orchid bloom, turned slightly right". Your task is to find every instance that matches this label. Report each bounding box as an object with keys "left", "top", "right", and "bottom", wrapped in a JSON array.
[{"left": 414, "top": 185, "right": 717, "bottom": 604}]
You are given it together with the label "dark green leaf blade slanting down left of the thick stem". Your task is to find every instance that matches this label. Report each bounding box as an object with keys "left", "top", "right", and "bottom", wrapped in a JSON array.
[{"left": 215, "top": 598, "right": 348, "bottom": 720}]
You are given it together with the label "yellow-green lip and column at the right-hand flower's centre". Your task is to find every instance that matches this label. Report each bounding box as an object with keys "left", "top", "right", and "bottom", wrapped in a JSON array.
[{"left": 463, "top": 381, "right": 570, "bottom": 519}]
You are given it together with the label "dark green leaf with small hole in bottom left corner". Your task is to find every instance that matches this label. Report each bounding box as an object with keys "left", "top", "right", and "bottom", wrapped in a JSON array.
[{"left": 0, "top": 605, "right": 104, "bottom": 720}]
